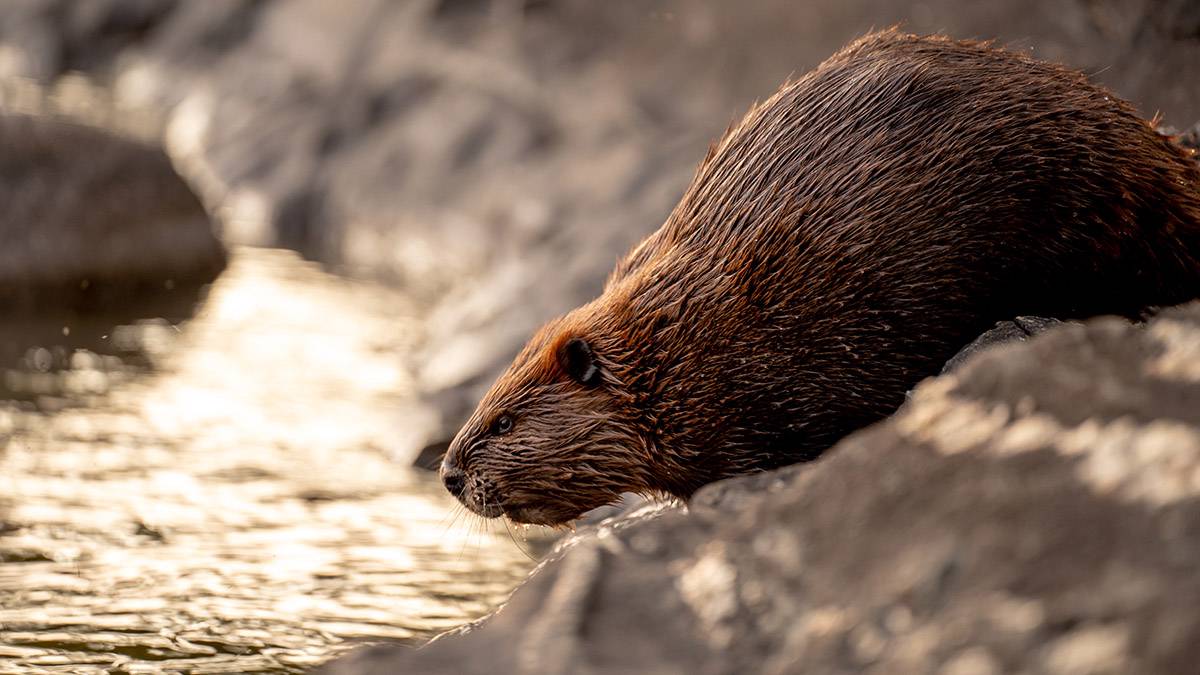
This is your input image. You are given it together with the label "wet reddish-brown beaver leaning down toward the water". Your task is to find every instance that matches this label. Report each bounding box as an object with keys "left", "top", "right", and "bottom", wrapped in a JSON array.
[{"left": 440, "top": 29, "right": 1200, "bottom": 525}]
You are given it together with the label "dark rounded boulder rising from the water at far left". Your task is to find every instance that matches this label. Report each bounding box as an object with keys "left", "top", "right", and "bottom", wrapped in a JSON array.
[{"left": 0, "top": 114, "right": 224, "bottom": 311}]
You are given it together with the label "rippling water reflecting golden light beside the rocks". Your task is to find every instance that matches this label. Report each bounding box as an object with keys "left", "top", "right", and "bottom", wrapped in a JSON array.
[{"left": 0, "top": 250, "right": 532, "bottom": 674}]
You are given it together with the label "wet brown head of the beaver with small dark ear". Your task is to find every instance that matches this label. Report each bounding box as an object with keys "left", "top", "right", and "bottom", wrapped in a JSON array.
[{"left": 440, "top": 310, "right": 655, "bottom": 525}]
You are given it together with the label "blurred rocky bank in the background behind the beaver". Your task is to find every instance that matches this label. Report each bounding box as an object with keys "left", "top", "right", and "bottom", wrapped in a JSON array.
[{"left": 0, "top": 0, "right": 1200, "bottom": 454}]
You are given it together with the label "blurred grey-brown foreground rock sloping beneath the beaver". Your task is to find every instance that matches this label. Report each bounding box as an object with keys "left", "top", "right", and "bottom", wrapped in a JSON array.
[{"left": 324, "top": 303, "right": 1200, "bottom": 675}]
